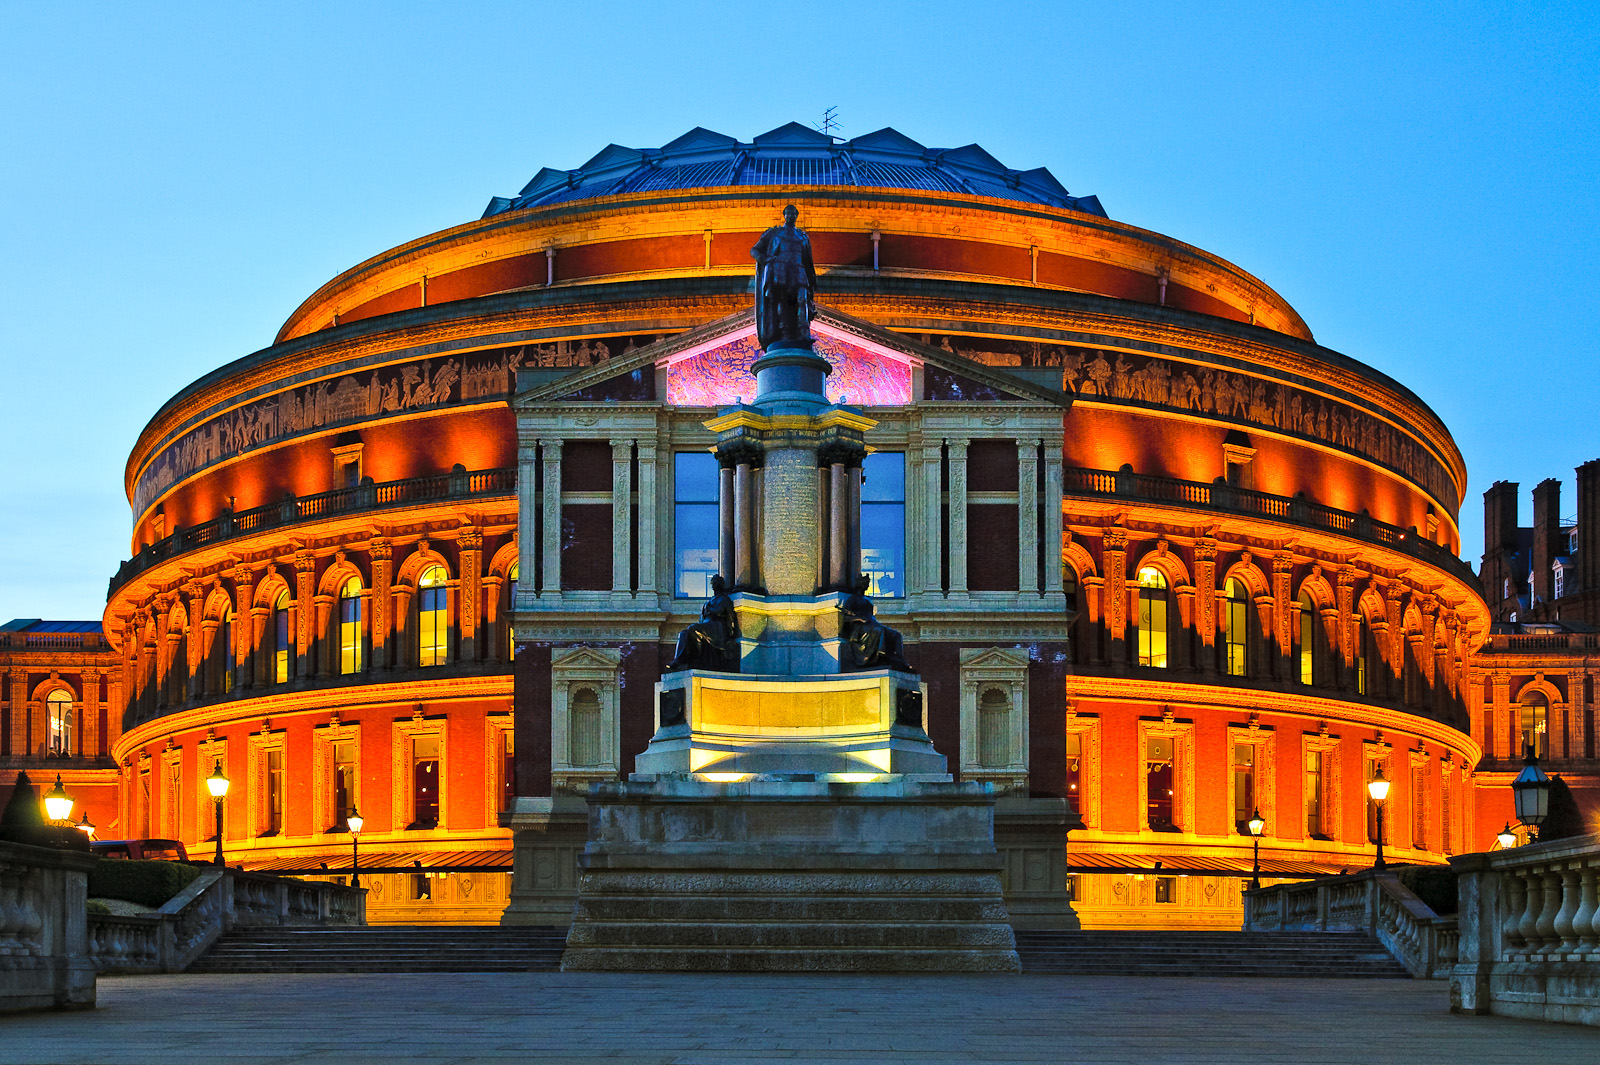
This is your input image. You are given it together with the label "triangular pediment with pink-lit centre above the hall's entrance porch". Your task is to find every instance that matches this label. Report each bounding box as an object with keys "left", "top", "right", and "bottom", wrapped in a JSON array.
[{"left": 517, "top": 305, "right": 1072, "bottom": 408}]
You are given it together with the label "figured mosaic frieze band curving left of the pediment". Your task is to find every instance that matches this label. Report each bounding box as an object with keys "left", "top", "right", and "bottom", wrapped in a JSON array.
[{"left": 133, "top": 336, "right": 662, "bottom": 515}]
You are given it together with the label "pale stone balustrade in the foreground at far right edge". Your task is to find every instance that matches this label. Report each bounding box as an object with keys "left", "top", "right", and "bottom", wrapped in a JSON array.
[{"left": 1450, "top": 836, "right": 1600, "bottom": 1025}]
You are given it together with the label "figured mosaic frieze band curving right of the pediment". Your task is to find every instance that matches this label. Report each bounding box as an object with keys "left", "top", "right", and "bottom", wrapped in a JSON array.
[{"left": 918, "top": 334, "right": 1461, "bottom": 510}]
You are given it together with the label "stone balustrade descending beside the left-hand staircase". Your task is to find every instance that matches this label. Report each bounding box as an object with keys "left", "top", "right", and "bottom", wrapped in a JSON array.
[{"left": 88, "top": 868, "right": 366, "bottom": 972}]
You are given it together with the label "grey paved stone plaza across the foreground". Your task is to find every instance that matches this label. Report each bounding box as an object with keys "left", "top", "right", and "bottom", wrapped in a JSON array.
[{"left": 0, "top": 972, "right": 1600, "bottom": 1065}]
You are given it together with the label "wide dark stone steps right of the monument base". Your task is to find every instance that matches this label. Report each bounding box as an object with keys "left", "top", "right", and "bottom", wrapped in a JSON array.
[{"left": 1016, "top": 931, "right": 1411, "bottom": 980}]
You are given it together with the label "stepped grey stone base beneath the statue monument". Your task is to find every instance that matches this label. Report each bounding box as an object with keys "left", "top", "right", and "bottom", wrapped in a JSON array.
[{"left": 562, "top": 776, "right": 1019, "bottom": 972}]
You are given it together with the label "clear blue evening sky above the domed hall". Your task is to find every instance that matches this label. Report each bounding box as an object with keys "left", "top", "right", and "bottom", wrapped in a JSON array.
[{"left": 0, "top": 0, "right": 1600, "bottom": 620}]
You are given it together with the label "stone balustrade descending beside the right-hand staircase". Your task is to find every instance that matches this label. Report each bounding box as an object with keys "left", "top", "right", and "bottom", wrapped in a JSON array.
[{"left": 1245, "top": 870, "right": 1461, "bottom": 980}]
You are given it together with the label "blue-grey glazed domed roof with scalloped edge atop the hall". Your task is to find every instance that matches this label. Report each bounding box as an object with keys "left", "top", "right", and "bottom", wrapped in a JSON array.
[{"left": 483, "top": 122, "right": 1107, "bottom": 217}]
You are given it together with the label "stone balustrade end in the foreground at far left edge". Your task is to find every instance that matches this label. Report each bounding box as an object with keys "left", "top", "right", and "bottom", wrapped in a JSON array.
[{"left": 0, "top": 843, "right": 96, "bottom": 1012}]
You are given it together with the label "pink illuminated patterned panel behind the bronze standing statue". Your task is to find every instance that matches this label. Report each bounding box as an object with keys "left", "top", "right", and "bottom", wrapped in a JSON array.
[{"left": 667, "top": 331, "right": 912, "bottom": 406}]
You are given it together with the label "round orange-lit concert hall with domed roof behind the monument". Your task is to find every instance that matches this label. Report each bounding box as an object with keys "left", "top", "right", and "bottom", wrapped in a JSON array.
[{"left": 102, "top": 125, "right": 1509, "bottom": 927}]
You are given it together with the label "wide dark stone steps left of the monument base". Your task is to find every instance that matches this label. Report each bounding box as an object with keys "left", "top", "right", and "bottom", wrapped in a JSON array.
[{"left": 189, "top": 924, "right": 566, "bottom": 972}]
